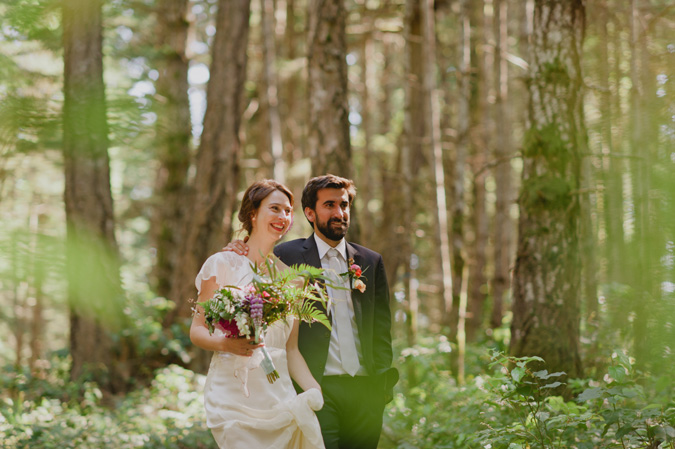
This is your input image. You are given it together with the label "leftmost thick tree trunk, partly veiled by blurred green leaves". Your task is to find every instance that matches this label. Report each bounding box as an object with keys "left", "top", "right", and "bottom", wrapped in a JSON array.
[{"left": 63, "top": 0, "right": 128, "bottom": 392}]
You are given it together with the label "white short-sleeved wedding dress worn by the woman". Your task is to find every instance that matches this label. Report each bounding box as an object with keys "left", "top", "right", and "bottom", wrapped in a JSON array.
[{"left": 195, "top": 252, "right": 324, "bottom": 449}]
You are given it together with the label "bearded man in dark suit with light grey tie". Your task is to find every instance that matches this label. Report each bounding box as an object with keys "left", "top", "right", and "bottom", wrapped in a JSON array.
[{"left": 228, "top": 175, "right": 398, "bottom": 449}]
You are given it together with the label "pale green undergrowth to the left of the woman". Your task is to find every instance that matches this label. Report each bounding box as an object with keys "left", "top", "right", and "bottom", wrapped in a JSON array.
[{"left": 0, "top": 365, "right": 216, "bottom": 449}]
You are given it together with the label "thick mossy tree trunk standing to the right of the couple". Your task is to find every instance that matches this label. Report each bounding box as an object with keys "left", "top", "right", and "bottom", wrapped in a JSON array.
[{"left": 510, "top": 0, "right": 586, "bottom": 378}]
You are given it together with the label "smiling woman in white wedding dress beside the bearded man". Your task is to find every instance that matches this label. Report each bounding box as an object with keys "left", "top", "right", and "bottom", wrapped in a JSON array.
[{"left": 190, "top": 180, "right": 324, "bottom": 449}]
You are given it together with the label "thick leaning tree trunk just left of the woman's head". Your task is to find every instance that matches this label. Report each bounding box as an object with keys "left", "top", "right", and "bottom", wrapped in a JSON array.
[{"left": 164, "top": 0, "right": 250, "bottom": 327}]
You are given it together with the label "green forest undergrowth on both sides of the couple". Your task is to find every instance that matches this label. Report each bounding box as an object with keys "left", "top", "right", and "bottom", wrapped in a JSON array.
[{"left": 0, "top": 336, "right": 675, "bottom": 449}]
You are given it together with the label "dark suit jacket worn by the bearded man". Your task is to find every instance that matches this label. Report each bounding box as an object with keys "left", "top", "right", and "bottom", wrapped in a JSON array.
[{"left": 274, "top": 235, "right": 398, "bottom": 397}]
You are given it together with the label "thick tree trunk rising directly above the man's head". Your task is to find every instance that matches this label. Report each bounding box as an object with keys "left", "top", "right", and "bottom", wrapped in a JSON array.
[{"left": 307, "top": 0, "right": 352, "bottom": 178}]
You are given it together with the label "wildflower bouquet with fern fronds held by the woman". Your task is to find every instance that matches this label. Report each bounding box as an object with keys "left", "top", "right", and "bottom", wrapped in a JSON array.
[{"left": 201, "top": 258, "right": 331, "bottom": 383}]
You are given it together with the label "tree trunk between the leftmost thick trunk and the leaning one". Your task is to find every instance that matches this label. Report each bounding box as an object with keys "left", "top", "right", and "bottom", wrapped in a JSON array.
[{"left": 150, "top": 0, "right": 192, "bottom": 297}]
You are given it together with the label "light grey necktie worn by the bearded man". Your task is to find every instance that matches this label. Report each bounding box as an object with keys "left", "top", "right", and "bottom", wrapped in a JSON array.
[{"left": 327, "top": 248, "right": 359, "bottom": 376}]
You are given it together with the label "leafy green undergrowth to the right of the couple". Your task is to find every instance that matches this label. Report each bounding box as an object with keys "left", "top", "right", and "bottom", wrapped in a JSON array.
[{"left": 380, "top": 337, "right": 675, "bottom": 449}]
